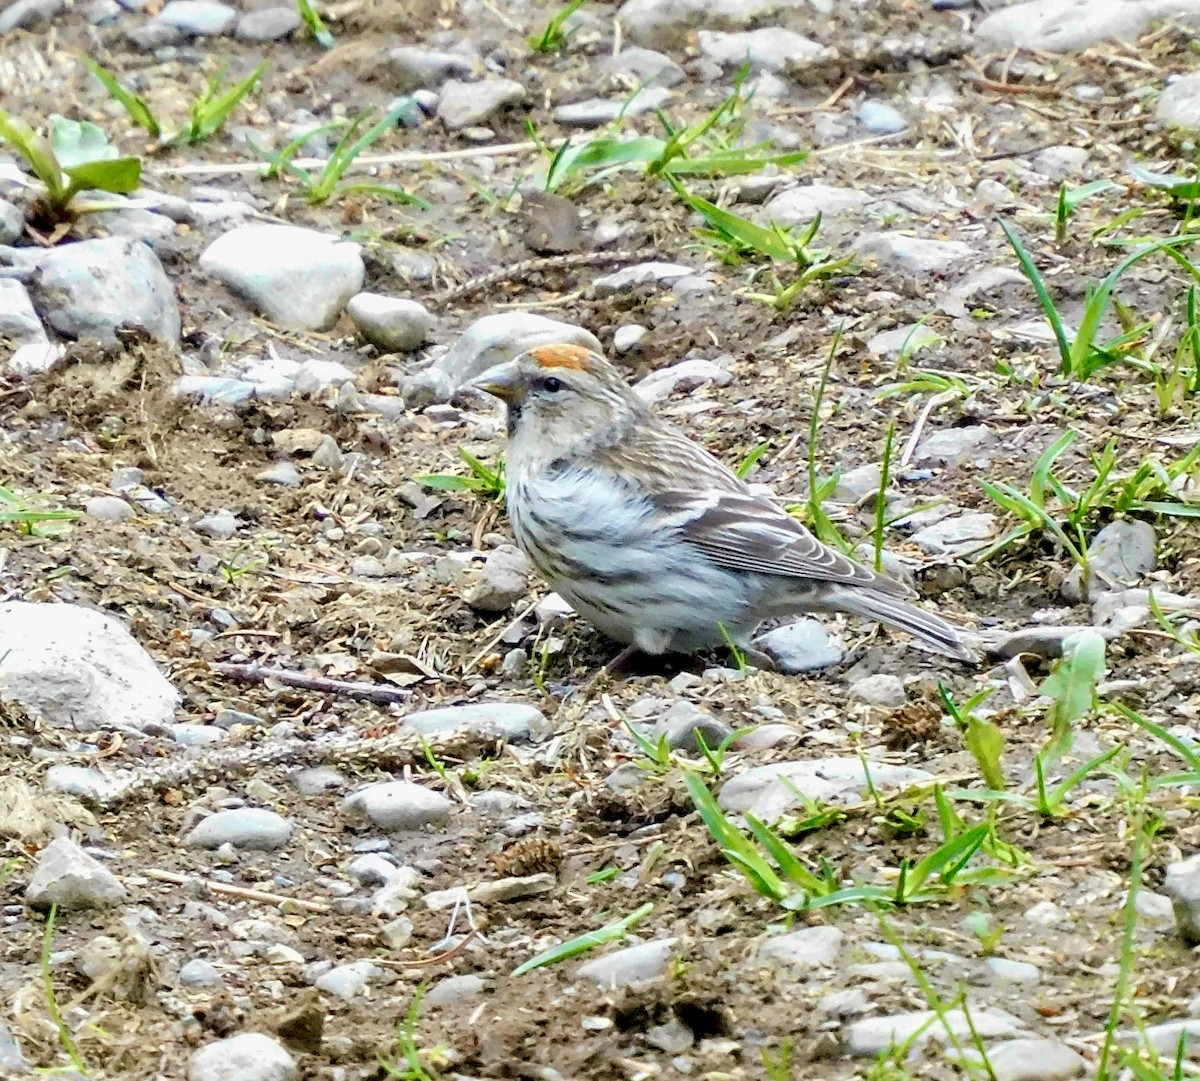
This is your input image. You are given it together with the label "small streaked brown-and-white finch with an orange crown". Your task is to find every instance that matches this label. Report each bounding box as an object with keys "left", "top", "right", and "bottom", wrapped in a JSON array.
[{"left": 474, "top": 346, "right": 973, "bottom": 663}]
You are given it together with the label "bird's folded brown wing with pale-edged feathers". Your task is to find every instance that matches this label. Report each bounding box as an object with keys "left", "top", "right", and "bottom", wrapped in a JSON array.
[{"left": 610, "top": 427, "right": 912, "bottom": 596}]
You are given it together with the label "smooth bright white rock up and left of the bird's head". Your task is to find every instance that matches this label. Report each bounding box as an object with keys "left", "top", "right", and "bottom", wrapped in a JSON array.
[{"left": 200, "top": 226, "right": 366, "bottom": 330}]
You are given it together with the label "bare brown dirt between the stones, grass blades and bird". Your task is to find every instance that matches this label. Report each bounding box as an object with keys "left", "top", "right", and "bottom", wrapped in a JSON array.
[{"left": 0, "top": 2, "right": 1200, "bottom": 1081}]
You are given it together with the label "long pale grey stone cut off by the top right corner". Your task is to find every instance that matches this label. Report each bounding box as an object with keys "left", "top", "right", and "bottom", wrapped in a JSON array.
[{"left": 974, "top": 0, "right": 1200, "bottom": 53}]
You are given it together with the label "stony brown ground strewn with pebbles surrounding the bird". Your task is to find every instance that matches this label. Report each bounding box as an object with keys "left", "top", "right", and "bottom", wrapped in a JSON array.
[{"left": 0, "top": 0, "right": 1200, "bottom": 1081}]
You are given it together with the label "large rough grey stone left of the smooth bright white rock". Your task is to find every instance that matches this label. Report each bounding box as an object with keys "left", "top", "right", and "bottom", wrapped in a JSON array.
[{"left": 30, "top": 236, "right": 180, "bottom": 346}]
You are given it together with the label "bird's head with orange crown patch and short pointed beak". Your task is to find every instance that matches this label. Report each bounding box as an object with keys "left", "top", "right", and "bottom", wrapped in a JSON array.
[{"left": 472, "top": 344, "right": 646, "bottom": 456}]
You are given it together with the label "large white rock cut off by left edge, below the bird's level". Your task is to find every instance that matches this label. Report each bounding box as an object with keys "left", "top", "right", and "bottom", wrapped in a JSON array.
[{"left": 0, "top": 601, "right": 179, "bottom": 731}]
